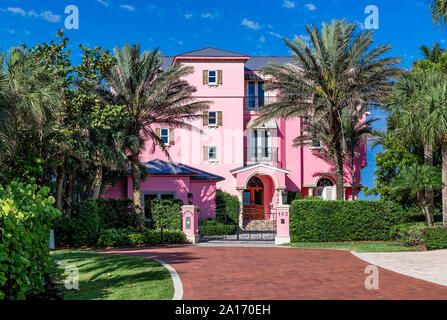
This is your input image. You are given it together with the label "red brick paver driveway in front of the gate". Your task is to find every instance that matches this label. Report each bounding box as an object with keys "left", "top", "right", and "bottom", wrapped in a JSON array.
[{"left": 101, "top": 246, "right": 447, "bottom": 300}]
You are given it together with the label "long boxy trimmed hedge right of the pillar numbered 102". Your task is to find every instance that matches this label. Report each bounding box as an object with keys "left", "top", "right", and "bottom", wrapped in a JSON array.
[{"left": 290, "top": 200, "right": 404, "bottom": 242}]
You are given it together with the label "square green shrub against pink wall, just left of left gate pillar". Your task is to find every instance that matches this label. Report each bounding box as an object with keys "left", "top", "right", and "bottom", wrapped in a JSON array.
[{"left": 151, "top": 199, "right": 183, "bottom": 230}]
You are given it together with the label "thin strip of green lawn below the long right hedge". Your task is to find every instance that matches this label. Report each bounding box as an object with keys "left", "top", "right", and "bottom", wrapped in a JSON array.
[{"left": 286, "top": 241, "right": 421, "bottom": 252}]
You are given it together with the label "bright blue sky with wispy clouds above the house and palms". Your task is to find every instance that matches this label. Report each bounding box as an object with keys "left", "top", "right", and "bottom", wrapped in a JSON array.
[{"left": 0, "top": 0, "right": 447, "bottom": 199}]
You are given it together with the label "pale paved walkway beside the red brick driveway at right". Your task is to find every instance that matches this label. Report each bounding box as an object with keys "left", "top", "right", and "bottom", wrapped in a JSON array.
[{"left": 355, "top": 250, "right": 447, "bottom": 288}]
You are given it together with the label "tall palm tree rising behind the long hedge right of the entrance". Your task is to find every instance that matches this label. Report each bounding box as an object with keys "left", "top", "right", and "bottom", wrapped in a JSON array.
[{"left": 258, "top": 20, "right": 401, "bottom": 200}]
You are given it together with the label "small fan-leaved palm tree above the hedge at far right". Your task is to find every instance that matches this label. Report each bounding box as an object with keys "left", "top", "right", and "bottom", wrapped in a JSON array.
[{"left": 391, "top": 163, "right": 442, "bottom": 226}]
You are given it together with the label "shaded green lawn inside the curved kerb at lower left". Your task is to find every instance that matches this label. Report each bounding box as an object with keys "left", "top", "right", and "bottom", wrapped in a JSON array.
[{"left": 51, "top": 250, "right": 174, "bottom": 300}]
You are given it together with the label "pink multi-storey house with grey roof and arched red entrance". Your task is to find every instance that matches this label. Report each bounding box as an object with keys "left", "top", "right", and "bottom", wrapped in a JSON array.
[{"left": 105, "top": 48, "right": 366, "bottom": 229}]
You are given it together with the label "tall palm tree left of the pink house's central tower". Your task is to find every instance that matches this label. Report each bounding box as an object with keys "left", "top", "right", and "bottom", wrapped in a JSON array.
[{"left": 100, "top": 45, "right": 208, "bottom": 226}]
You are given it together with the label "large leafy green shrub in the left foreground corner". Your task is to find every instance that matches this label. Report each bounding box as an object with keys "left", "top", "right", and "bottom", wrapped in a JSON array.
[{"left": 0, "top": 181, "right": 61, "bottom": 300}]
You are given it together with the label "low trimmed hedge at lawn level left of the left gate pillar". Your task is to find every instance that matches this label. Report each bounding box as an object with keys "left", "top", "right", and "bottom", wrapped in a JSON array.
[{"left": 97, "top": 228, "right": 186, "bottom": 247}]
